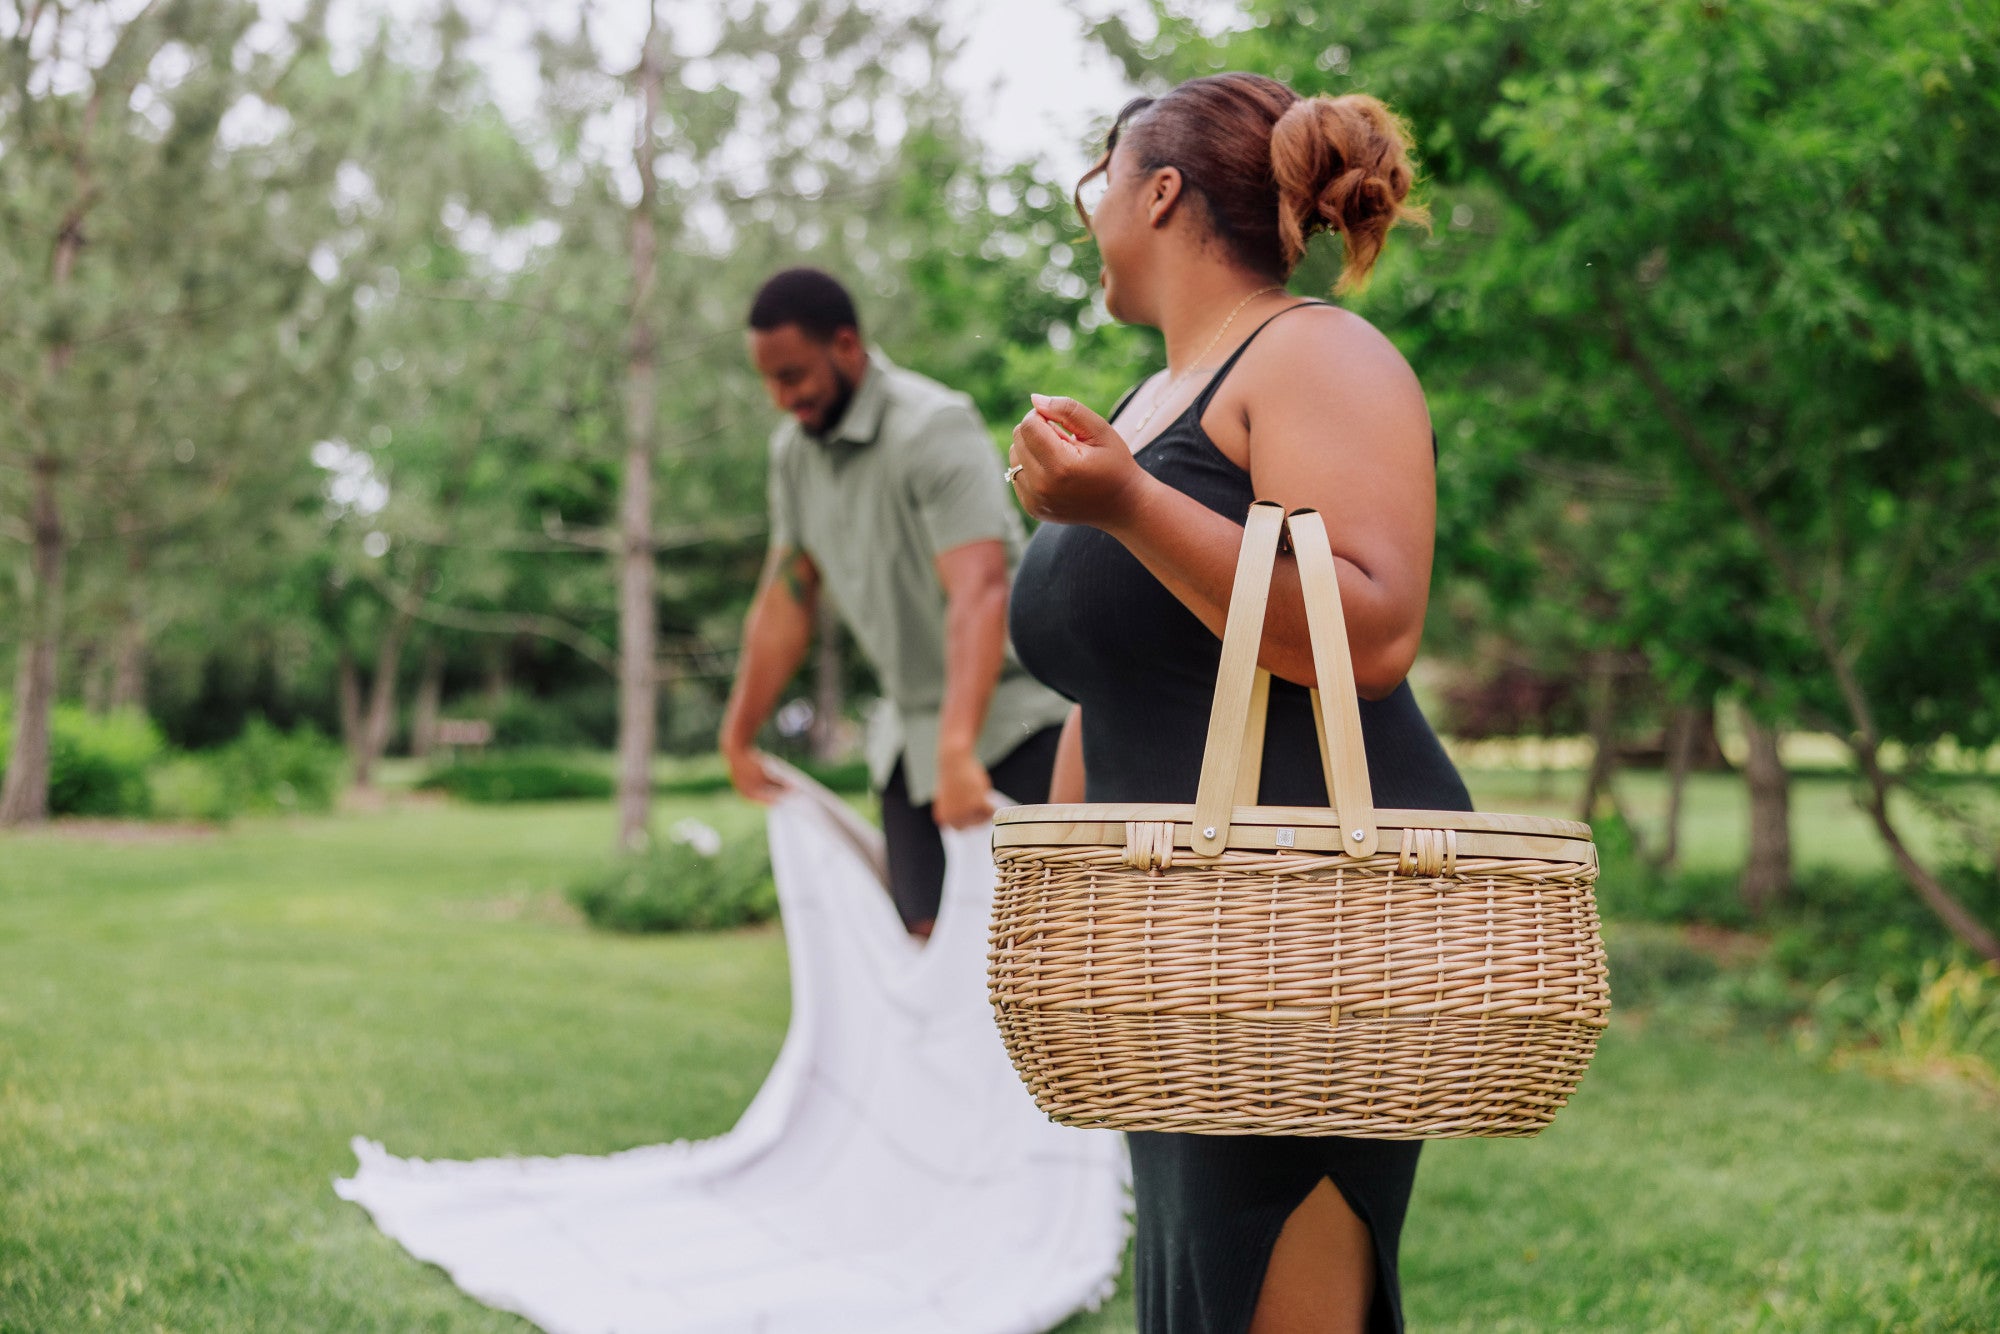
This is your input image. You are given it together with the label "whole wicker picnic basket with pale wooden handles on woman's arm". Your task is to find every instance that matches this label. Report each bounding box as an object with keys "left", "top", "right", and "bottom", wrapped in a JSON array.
[{"left": 988, "top": 502, "right": 1610, "bottom": 1140}]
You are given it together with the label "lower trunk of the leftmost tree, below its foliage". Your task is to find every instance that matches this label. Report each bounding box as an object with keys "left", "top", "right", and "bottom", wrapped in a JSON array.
[{"left": 0, "top": 464, "right": 68, "bottom": 826}]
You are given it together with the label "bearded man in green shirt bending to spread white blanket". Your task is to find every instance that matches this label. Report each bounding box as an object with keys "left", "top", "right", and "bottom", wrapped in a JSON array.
[{"left": 720, "top": 268, "right": 1068, "bottom": 936}]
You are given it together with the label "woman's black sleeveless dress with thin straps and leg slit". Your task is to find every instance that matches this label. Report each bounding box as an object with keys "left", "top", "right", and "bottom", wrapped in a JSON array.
[{"left": 1010, "top": 302, "right": 1472, "bottom": 1334}]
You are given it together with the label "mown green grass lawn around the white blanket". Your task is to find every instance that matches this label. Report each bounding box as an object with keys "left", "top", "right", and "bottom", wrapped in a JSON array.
[{"left": 0, "top": 778, "right": 2000, "bottom": 1334}]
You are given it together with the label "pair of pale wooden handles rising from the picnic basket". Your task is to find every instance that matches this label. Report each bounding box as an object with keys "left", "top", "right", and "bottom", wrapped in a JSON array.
[{"left": 1190, "top": 500, "right": 1378, "bottom": 856}]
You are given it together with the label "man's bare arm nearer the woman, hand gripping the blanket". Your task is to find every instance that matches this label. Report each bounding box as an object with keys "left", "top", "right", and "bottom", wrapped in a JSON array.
[{"left": 930, "top": 540, "right": 1008, "bottom": 828}]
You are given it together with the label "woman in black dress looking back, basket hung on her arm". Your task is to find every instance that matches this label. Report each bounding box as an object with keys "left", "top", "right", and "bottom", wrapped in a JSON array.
[{"left": 1008, "top": 74, "right": 1472, "bottom": 1334}]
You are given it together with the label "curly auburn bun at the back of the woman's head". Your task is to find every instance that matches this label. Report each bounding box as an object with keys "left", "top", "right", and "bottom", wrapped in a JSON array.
[{"left": 1270, "top": 92, "right": 1428, "bottom": 290}]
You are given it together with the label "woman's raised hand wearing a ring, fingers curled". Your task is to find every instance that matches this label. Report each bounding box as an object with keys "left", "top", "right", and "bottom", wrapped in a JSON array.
[{"left": 1008, "top": 394, "right": 1152, "bottom": 530}]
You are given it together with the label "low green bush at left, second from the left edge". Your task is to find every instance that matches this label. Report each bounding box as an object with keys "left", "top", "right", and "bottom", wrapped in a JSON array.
[{"left": 152, "top": 718, "right": 346, "bottom": 820}]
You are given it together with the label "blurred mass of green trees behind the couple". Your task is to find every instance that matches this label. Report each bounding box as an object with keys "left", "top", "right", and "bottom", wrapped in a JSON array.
[{"left": 0, "top": 0, "right": 2000, "bottom": 956}]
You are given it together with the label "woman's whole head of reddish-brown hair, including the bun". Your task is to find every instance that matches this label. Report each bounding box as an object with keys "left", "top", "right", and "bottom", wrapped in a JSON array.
[{"left": 1076, "top": 74, "right": 1430, "bottom": 290}]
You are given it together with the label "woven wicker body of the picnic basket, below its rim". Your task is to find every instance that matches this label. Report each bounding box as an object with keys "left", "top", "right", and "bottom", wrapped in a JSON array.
[{"left": 990, "top": 848, "right": 1610, "bottom": 1138}]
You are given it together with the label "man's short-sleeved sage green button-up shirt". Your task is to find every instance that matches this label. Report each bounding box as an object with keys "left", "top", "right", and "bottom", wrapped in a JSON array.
[{"left": 770, "top": 352, "right": 1068, "bottom": 804}]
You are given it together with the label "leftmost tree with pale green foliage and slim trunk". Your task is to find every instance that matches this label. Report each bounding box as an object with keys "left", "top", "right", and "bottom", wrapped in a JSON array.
[{"left": 0, "top": 0, "right": 376, "bottom": 824}]
